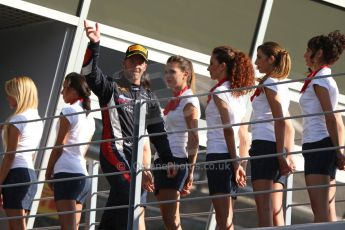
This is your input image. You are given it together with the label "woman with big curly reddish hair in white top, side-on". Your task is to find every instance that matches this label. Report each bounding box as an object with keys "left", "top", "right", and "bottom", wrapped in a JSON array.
[{"left": 205, "top": 46, "right": 254, "bottom": 229}]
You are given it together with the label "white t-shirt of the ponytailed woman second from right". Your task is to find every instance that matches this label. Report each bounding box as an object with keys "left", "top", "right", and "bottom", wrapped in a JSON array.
[{"left": 251, "top": 77, "right": 290, "bottom": 142}]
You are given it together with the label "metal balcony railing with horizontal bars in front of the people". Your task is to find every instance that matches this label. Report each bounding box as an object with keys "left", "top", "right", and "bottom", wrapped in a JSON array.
[{"left": 0, "top": 71, "right": 345, "bottom": 229}]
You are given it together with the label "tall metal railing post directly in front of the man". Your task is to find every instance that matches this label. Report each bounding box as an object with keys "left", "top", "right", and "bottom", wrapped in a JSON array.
[{"left": 127, "top": 99, "right": 147, "bottom": 230}]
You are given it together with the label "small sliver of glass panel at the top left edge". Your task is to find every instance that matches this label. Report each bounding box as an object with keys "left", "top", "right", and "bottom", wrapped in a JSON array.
[{"left": 24, "top": 0, "right": 79, "bottom": 15}]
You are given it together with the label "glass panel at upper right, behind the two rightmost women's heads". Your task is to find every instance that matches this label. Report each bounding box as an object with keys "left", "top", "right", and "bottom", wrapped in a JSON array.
[{"left": 265, "top": 0, "right": 345, "bottom": 93}]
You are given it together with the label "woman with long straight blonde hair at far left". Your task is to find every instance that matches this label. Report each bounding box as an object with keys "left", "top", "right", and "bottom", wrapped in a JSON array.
[{"left": 0, "top": 76, "right": 43, "bottom": 229}]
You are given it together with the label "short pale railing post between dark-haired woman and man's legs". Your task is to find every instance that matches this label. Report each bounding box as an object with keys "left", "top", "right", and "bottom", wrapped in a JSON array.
[{"left": 85, "top": 160, "right": 99, "bottom": 230}]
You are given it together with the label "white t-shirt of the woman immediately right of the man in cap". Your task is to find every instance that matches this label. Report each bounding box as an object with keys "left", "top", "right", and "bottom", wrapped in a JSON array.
[{"left": 155, "top": 89, "right": 200, "bottom": 159}]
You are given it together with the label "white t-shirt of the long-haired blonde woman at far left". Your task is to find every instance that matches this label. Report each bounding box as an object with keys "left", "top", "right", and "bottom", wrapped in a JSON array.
[{"left": 10, "top": 109, "right": 43, "bottom": 169}]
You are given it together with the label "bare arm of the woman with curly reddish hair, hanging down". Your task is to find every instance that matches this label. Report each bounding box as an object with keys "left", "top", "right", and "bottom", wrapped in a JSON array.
[{"left": 213, "top": 95, "right": 246, "bottom": 186}]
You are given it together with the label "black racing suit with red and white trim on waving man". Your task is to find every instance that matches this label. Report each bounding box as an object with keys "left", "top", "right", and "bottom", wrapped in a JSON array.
[{"left": 82, "top": 42, "right": 173, "bottom": 229}]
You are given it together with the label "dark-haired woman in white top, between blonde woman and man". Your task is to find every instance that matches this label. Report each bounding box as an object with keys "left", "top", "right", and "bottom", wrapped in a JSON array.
[{"left": 46, "top": 73, "right": 95, "bottom": 229}]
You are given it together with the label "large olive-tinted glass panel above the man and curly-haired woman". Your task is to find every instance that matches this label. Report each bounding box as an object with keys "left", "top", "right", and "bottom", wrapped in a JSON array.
[{"left": 88, "top": 0, "right": 262, "bottom": 54}]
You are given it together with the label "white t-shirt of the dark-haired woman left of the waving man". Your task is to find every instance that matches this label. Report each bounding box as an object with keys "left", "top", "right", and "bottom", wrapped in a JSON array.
[{"left": 54, "top": 101, "right": 95, "bottom": 175}]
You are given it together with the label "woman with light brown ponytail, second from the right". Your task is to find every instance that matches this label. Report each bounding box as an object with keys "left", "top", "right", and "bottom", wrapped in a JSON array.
[{"left": 249, "top": 42, "right": 295, "bottom": 227}]
